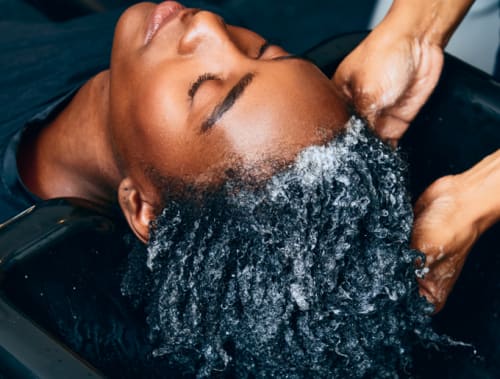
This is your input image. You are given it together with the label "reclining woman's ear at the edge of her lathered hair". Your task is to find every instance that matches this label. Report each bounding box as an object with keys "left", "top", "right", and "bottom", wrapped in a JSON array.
[{"left": 118, "top": 177, "right": 155, "bottom": 243}]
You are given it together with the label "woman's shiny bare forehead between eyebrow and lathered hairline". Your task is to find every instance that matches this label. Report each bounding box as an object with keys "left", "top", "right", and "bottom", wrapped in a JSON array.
[{"left": 218, "top": 60, "right": 339, "bottom": 159}]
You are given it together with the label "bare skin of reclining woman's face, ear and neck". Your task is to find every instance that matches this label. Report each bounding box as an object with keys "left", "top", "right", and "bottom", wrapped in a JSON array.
[{"left": 19, "top": 3, "right": 348, "bottom": 242}]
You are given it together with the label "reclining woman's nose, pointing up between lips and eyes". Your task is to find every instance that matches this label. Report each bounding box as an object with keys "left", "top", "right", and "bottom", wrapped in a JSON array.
[{"left": 178, "top": 11, "right": 234, "bottom": 54}]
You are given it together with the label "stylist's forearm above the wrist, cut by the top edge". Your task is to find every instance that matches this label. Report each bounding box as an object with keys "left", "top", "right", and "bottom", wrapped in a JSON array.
[{"left": 384, "top": 0, "right": 474, "bottom": 48}]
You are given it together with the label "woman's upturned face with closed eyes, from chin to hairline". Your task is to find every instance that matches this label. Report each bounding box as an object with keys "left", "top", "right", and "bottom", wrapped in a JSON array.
[{"left": 110, "top": 2, "right": 347, "bottom": 202}]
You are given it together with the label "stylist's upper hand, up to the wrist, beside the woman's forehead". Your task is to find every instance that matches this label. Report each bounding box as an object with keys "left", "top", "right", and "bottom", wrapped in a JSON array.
[{"left": 334, "top": 23, "right": 443, "bottom": 145}]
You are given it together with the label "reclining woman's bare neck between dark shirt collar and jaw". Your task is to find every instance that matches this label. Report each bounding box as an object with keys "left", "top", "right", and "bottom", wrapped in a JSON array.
[{"left": 18, "top": 71, "right": 120, "bottom": 208}]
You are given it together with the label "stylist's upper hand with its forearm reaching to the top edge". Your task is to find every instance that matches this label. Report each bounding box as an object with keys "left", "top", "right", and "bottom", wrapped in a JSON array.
[{"left": 333, "top": 0, "right": 473, "bottom": 145}]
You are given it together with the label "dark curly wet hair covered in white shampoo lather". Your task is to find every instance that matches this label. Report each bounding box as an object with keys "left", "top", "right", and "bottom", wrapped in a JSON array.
[{"left": 122, "top": 118, "right": 438, "bottom": 378}]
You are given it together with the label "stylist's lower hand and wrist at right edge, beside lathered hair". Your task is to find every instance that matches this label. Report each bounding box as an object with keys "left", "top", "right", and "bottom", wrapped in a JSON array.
[{"left": 411, "top": 149, "right": 500, "bottom": 312}]
